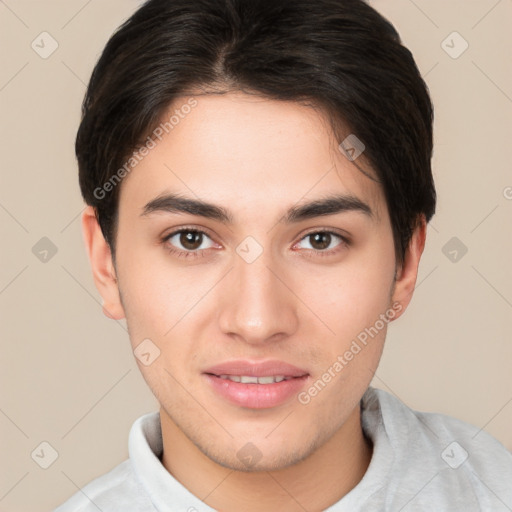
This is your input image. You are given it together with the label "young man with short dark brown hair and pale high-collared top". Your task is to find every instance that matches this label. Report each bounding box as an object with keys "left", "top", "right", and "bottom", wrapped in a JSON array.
[{"left": 57, "top": 0, "right": 512, "bottom": 512}]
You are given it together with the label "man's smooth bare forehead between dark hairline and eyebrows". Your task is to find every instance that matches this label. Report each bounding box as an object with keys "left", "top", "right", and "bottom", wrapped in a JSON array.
[{"left": 120, "top": 93, "right": 386, "bottom": 219}]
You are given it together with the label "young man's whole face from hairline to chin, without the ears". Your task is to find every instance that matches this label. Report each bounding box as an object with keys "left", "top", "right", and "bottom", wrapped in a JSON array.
[{"left": 95, "top": 93, "right": 408, "bottom": 469}]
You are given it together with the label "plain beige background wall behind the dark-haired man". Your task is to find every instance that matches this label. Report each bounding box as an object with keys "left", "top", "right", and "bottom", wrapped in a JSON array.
[{"left": 0, "top": 0, "right": 512, "bottom": 512}]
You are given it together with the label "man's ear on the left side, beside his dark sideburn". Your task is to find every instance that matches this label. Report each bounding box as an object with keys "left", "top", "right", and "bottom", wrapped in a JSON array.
[{"left": 82, "top": 206, "right": 125, "bottom": 320}]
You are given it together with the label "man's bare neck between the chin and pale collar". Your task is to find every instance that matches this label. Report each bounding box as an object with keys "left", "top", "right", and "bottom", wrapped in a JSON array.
[{"left": 160, "top": 404, "right": 372, "bottom": 512}]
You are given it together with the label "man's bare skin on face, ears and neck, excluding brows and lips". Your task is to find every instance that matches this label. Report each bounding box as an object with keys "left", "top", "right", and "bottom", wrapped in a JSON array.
[{"left": 82, "top": 93, "right": 426, "bottom": 512}]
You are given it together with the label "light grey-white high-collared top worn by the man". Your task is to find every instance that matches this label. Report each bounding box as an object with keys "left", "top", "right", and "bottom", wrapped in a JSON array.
[{"left": 54, "top": 388, "right": 512, "bottom": 512}]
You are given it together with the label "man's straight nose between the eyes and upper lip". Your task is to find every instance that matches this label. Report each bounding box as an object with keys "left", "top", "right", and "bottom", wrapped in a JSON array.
[{"left": 219, "top": 252, "right": 298, "bottom": 344}]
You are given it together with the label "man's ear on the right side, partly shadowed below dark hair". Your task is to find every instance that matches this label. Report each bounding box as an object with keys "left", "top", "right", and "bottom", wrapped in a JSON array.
[{"left": 392, "top": 215, "right": 427, "bottom": 320}]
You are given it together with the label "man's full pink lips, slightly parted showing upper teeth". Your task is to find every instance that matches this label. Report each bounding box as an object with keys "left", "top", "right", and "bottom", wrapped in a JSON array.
[{"left": 203, "top": 361, "right": 309, "bottom": 409}]
